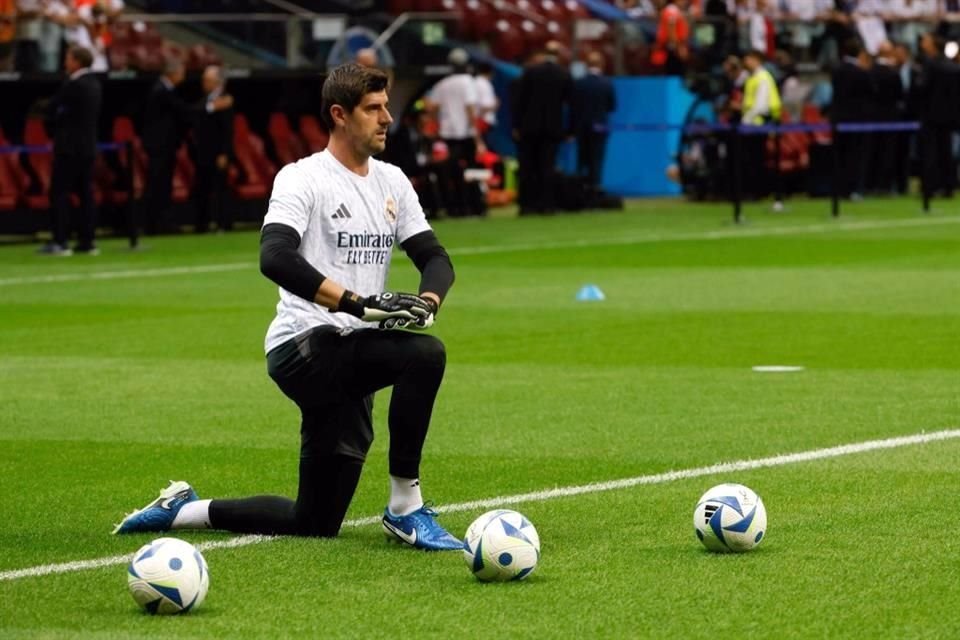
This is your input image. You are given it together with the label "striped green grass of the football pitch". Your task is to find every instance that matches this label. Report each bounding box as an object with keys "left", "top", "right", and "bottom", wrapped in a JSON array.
[{"left": 0, "top": 200, "right": 960, "bottom": 638}]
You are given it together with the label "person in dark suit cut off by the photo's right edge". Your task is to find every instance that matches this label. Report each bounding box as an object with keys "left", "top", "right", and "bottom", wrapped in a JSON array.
[{"left": 916, "top": 33, "right": 960, "bottom": 198}]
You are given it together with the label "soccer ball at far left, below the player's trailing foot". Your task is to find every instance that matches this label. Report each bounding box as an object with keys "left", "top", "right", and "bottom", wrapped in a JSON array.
[{"left": 127, "top": 538, "right": 210, "bottom": 614}]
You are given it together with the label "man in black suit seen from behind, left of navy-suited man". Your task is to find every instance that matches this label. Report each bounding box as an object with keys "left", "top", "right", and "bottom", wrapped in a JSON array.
[{"left": 512, "top": 42, "right": 573, "bottom": 214}]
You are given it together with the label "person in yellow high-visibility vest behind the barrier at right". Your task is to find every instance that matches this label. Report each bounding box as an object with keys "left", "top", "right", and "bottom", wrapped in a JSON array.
[{"left": 741, "top": 50, "right": 782, "bottom": 201}]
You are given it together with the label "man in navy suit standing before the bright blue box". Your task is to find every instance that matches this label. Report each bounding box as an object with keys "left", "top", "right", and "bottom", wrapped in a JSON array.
[{"left": 570, "top": 51, "right": 617, "bottom": 199}]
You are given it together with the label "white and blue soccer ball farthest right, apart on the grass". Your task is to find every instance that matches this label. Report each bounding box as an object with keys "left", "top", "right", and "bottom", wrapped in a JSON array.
[{"left": 693, "top": 484, "right": 767, "bottom": 553}]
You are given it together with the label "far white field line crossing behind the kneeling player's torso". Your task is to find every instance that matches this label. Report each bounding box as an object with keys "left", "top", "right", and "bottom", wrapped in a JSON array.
[{"left": 0, "top": 216, "right": 960, "bottom": 287}]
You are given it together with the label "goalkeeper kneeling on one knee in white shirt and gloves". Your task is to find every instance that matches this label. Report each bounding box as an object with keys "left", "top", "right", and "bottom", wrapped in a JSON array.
[{"left": 115, "top": 63, "right": 463, "bottom": 550}]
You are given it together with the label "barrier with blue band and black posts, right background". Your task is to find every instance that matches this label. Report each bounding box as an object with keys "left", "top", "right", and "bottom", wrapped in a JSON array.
[{"left": 594, "top": 120, "right": 930, "bottom": 224}]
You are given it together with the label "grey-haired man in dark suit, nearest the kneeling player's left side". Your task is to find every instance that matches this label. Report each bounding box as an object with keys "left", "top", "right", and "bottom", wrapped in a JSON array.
[{"left": 193, "top": 65, "right": 233, "bottom": 233}]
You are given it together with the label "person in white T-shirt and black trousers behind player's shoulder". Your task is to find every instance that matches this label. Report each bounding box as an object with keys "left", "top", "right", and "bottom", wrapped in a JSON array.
[{"left": 426, "top": 49, "right": 484, "bottom": 217}]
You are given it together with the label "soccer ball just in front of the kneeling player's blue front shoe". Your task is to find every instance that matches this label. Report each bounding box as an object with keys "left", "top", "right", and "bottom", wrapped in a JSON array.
[{"left": 463, "top": 509, "right": 540, "bottom": 582}]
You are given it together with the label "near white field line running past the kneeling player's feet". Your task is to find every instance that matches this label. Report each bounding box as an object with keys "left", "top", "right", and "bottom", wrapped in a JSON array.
[{"left": 0, "top": 429, "right": 960, "bottom": 582}]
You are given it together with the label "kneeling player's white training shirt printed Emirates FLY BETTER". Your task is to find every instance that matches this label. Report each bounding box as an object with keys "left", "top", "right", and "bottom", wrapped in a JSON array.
[{"left": 263, "top": 151, "right": 430, "bottom": 352}]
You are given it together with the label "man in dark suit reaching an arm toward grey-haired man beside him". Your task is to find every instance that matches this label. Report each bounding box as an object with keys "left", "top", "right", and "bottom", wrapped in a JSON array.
[{"left": 142, "top": 59, "right": 233, "bottom": 239}]
